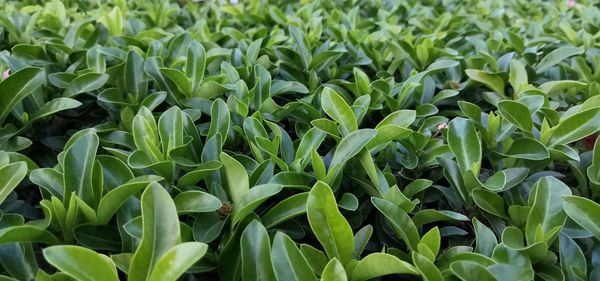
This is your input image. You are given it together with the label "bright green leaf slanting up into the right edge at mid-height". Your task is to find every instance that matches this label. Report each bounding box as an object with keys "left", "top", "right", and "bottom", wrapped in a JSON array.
[{"left": 548, "top": 108, "right": 600, "bottom": 147}]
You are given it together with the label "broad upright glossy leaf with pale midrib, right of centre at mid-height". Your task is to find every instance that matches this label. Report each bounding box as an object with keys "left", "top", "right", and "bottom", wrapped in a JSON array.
[{"left": 448, "top": 118, "right": 481, "bottom": 177}]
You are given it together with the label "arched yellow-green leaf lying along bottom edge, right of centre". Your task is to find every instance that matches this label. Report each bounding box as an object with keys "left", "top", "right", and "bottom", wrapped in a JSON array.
[{"left": 352, "top": 253, "right": 419, "bottom": 281}]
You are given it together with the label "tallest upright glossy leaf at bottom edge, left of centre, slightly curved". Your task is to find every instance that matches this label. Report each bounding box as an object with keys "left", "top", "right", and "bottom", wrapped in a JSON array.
[{"left": 128, "top": 183, "right": 181, "bottom": 280}]
